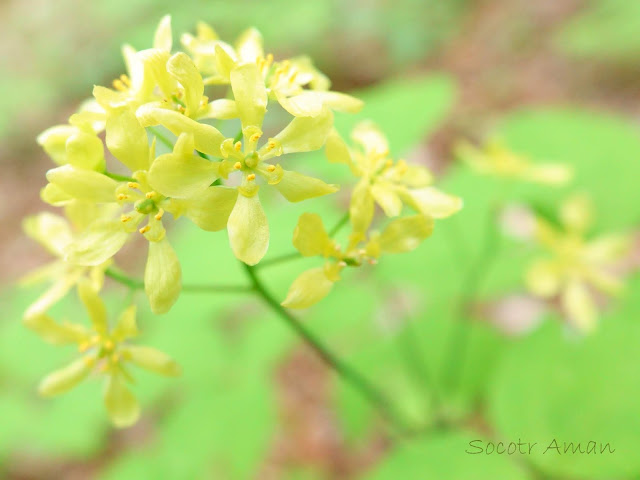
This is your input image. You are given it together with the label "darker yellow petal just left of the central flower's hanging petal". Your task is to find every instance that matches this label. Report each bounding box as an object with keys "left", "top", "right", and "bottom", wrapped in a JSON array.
[{"left": 174, "top": 186, "right": 238, "bottom": 232}]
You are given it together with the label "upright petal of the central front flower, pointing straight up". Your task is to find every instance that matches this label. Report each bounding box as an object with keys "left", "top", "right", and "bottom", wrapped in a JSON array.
[{"left": 231, "top": 63, "right": 267, "bottom": 129}]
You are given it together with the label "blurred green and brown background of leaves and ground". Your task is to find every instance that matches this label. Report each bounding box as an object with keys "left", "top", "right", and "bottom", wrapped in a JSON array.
[{"left": 0, "top": 0, "right": 640, "bottom": 480}]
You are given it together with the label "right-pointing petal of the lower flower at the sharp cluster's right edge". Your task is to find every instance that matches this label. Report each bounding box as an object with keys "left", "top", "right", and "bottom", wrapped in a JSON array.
[{"left": 377, "top": 215, "right": 433, "bottom": 253}]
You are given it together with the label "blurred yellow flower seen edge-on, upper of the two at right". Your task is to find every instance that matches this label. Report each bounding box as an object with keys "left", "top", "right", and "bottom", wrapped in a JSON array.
[{"left": 456, "top": 139, "right": 573, "bottom": 186}]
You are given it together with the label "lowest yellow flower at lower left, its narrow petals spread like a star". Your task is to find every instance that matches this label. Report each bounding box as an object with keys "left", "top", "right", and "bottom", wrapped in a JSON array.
[{"left": 25, "top": 282, "right": 180, "bottom": 427}]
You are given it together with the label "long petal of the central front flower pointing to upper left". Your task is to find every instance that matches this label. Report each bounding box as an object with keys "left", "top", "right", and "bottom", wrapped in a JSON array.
[{"left": 136, "top": 104, "right": 224, "bottom": 157}]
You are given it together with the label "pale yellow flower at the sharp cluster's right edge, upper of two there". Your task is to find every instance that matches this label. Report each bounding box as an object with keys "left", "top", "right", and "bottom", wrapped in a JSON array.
[{"left": 326, "top": 122, "right": 462, "bottom": 235}]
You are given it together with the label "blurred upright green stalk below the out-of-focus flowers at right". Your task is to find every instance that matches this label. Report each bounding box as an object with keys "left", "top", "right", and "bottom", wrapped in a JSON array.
[{"left": 443, "top": 208, "right": 500, "bottom": 393}]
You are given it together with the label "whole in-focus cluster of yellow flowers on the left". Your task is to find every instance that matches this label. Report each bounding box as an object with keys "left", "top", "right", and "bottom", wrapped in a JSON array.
[{"left": 24, "top": 17, "right": 462, "bottom": 425}]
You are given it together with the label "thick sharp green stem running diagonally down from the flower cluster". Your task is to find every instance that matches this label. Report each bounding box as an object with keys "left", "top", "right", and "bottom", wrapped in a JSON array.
[{"left": 242, "top": 263, "right": 408, "bottom": 433}]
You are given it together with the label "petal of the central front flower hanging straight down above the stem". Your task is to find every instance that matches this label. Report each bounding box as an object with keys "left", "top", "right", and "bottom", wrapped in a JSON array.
[{"left": 227, "top": 195, "right": 269, "bottom": 265}]
